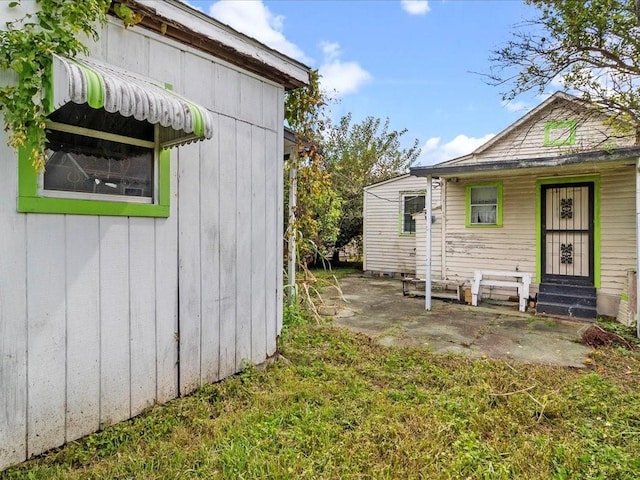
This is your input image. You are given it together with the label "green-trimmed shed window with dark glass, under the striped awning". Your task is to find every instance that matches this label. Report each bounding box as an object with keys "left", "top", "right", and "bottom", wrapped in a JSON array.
[{"left": 18, "top": 103, "right": 169, "bottom": 217}]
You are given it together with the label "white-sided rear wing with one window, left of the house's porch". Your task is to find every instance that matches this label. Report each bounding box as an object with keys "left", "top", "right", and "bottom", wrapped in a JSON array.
[{"left": 363, "top": 174, "right": 442, "bottom": 278}]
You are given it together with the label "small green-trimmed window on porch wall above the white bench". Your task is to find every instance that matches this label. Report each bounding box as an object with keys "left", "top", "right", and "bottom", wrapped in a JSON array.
[{"left": 466, "top": 183, "right": 502, "bottom": 227}]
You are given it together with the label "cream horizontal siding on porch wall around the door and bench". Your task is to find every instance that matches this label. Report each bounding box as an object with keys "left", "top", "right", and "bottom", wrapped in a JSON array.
[{"left": 445, "top": 166, "right": 636, "bottom": 306}]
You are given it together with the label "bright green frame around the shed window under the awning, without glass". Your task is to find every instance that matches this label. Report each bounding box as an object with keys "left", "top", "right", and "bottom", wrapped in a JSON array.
[{"left": 17, "top": 125, "right": 171, "bottom": 218}]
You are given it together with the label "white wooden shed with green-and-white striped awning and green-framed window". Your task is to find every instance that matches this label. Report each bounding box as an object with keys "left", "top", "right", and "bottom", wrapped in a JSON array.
[{"left": 0, "top": 0, "right": 308, "bottom": 470}]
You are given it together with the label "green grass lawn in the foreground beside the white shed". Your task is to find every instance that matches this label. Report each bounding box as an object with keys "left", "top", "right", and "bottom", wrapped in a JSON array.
[{"left": 0, "top": 322, "right": 640, "bottom": 479}]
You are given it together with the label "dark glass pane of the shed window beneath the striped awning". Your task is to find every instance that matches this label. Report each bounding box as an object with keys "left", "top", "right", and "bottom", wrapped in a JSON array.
[{"left": 44, "top": 130, "right": 153, "bottom": 198}]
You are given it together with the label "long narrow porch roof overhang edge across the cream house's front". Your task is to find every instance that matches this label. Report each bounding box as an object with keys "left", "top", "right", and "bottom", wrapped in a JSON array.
[{"left": 410, "top": 146, "right": 640, "bottom": 178}]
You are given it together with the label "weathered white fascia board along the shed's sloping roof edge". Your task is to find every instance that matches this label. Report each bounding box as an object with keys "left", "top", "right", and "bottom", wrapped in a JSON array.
[{"left": 129, "top": 0, "right": 309, "bottom": 89}]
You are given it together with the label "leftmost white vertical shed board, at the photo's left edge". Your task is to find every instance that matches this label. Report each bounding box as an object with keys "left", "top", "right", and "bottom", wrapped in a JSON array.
[{"left": 0, "top": 137, "right": 27, "bottom": 470}]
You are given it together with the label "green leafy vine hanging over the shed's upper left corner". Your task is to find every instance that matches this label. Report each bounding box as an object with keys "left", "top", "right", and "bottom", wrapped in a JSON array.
[{"left": 0, "top": 0, "right": 111, "bottom": 170}]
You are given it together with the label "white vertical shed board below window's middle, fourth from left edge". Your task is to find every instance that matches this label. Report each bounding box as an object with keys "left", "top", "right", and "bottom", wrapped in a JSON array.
[{"left": 100, "top": 217, "right": 131, "bottom": 425}]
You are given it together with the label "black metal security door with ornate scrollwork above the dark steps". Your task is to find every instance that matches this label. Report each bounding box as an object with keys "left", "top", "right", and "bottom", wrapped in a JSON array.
[{"left": 541, "top": 183, "right": 593, "bottom": 284}]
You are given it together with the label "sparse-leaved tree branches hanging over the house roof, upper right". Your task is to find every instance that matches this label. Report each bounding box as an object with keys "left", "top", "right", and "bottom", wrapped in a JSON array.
[{"left": 489, "top": 0, "right": 640, "bottom": 143}]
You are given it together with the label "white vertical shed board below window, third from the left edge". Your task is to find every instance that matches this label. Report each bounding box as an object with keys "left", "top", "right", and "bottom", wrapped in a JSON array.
[{"left": 65, "top": 215, "right": 100, "bottom": 441}]
